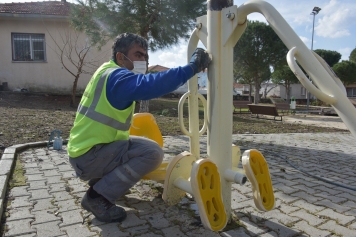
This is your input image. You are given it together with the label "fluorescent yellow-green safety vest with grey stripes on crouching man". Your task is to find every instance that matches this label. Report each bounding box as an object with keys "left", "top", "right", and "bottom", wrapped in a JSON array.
[{"left": 67, "top": 60, "right": 135, "bottom": 158}]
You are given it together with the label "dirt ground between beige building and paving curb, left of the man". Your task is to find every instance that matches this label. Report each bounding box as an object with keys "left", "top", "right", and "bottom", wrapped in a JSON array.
[{"left": 0, "top": 92, "right": 79, "bottom": 152}]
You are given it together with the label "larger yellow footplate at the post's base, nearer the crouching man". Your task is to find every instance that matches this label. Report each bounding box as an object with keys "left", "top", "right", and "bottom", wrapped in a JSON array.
[{"left": 190, "top": 159, "right": 228, "bottom": 231}]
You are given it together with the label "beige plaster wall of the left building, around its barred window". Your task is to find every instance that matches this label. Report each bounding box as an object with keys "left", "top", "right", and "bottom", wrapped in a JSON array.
[{"left": 0, "top": 14, "right": 111, "bottom": 94}]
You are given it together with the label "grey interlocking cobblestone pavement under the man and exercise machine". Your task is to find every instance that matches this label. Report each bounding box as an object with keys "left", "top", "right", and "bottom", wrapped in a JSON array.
[{"left": 0, "top": 133, "right": 356, "bottom": 237}]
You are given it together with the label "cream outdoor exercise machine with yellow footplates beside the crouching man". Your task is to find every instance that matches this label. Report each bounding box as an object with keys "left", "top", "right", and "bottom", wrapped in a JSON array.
[{"left": 134, "top": 0, "right": 356, "bottom": 231}]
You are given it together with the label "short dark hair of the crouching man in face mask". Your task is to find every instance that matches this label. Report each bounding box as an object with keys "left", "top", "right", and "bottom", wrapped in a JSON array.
[{"left": 112, "top": 33, "right": 148, "bottom": 64}]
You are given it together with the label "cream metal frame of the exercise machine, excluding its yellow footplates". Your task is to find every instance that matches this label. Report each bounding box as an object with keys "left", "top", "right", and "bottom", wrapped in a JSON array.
[{"left": 179, "top": 0, "right": 356, "bottom": 226}]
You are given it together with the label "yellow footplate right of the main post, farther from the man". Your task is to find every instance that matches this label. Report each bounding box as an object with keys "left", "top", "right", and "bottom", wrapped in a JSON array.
[{"left": 242, "top": 149, "right": 275, "bottom": 211}]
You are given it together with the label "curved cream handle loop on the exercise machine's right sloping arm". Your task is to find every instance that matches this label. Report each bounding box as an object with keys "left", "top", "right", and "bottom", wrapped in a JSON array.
[{"left": 287, "top": 47, "right": 337, "bottom": 105}]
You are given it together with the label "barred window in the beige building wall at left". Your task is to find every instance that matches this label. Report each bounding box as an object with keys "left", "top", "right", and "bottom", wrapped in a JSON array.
[{"left": 12, "top": 33, "right": 46, "bottom": 61}]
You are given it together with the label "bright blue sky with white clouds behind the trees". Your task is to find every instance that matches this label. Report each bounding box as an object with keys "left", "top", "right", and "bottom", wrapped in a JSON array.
[{"left": 0, "top": 0, "right": 356, "bottom": 68}]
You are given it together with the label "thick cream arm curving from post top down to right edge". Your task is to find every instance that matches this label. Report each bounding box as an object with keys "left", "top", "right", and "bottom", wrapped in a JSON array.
[{"left": 238, "top": 0, "right": 356, "bottom": 137}]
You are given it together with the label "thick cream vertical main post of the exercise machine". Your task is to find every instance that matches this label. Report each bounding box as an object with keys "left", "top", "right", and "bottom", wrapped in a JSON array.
[{"left": 207, "top": 0, "right": 233, "bottom": 218}]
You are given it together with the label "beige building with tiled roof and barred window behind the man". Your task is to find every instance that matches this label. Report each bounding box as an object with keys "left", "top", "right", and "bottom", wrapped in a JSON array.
[{"left": 0, "top": 0, "right": 111, "bottom": 94}]
